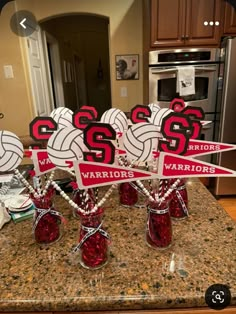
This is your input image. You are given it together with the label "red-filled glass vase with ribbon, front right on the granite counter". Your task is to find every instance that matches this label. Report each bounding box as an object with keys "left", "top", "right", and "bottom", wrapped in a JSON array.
[{"left": 146, "top": 201, "right": 172, "bottom": 249}]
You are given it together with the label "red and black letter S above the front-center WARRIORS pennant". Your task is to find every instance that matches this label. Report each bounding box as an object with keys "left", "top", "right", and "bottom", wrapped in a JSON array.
[{"left": 84, "top": 122, "right": 116, "bottom": 164}]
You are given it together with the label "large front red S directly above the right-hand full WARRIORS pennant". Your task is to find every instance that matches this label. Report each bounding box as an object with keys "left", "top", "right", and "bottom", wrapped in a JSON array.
[{"left": 158, "top": 112, "right": 192, "bottom": 155}]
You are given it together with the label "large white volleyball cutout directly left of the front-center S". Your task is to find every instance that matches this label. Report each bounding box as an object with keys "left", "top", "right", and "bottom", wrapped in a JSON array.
[{"left": 47, "top": 127, "right": 87, "bottom": 169}]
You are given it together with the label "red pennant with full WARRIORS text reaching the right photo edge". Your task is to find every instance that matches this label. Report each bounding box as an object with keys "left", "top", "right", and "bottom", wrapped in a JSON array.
[{"left": 158, "top": 153, "right": 236, "bottom": 178}]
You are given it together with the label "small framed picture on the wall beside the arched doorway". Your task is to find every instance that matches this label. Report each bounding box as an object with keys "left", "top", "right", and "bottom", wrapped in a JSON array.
[{"left": 116, "top": 55, "right": 139, "bottom": 80}]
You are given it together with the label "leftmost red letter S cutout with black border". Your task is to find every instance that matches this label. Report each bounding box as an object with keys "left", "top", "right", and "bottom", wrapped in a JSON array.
[{"left": 29, "top": 117, "right": 57, "bottom": 141}]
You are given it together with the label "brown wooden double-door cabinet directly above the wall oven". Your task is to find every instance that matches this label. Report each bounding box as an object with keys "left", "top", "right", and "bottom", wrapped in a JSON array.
[{"left": 150, "top": 0, "right": 222, "bottom": 48}]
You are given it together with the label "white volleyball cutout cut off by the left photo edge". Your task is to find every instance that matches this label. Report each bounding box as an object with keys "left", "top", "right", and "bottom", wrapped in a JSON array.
[{"left": 0, "top": 130, "right": 24, "bottom": 172}]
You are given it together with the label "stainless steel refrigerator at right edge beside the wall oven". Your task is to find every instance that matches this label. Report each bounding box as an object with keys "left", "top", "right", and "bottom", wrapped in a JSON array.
[{"left": 213, "top": 37, "right": 236, "bottom": 196}]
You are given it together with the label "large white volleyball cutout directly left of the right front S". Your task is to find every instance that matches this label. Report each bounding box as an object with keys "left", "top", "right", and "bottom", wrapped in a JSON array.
[{"left": 123, "top": 122, "right": 161, "bottom": 161}]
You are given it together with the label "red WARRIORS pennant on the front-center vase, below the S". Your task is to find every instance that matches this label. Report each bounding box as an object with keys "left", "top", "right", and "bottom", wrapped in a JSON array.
[{"left": 74, "top": 161, "right": 157, "bottom": 189}]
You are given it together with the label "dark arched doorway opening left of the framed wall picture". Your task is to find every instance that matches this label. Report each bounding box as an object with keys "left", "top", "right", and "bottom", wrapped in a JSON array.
[{"left": 39, "top": 14, "right": 112, "bottom": 118}]
